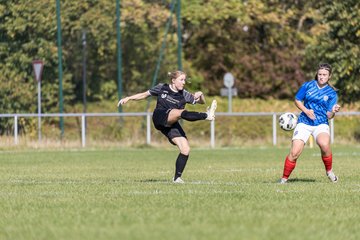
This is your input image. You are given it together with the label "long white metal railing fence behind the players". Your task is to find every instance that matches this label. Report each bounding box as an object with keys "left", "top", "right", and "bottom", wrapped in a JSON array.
[{"left": 0, "top": 112, "right": 360, "bottom": 148}]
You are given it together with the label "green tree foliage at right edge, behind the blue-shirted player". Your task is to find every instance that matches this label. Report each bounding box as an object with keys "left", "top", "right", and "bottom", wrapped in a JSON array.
[{"left": 307, "top": 0, "right": 360, "bottom": 102}]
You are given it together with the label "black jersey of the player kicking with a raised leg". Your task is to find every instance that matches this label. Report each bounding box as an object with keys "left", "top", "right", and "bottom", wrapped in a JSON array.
[{"left": 149, "top": 83, "right": 195, "bottom": 110}]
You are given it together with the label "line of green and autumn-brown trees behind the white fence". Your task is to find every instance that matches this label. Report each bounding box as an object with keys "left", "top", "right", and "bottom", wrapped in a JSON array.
[{"left": 0, "top": 0, "right": 360, "bottom": 120}]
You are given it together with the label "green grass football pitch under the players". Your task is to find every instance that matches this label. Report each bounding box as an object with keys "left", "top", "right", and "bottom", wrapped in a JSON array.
[{"left": 0, "top": 146, "right": 360, "bottom": 240}]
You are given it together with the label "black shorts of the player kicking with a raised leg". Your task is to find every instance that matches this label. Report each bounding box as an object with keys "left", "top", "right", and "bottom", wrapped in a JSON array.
[{"left": 153, "top": 109, "right": 186, "bottom": 145}]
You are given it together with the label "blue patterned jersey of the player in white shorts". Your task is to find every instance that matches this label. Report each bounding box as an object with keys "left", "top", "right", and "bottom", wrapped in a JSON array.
[{"left": 295, "top": 80, "right": 337, "bottom": 126}]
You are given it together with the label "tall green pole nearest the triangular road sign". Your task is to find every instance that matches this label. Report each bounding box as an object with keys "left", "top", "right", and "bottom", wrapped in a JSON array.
[{"left": 56, "top": 0, "right": 64, "bottom": 139}]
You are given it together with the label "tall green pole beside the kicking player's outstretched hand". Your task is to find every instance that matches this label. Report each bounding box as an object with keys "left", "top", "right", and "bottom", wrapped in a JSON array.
[{"left": 116, "top": 0, "right": 122, "bottom": 112}]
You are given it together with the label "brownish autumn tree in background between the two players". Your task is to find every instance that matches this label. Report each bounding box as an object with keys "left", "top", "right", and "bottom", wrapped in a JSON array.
[{"left": 183, "top": 0, "right": 315, "bottom": 98}]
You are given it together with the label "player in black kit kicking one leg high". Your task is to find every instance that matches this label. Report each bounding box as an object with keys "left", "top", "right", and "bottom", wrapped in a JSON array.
[{"left": 118, "top": 71, "right": 217, "bottom": 183}]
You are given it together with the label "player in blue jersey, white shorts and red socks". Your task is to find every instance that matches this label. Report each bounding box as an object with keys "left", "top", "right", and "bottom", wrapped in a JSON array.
[{"left": 280, "top": 63, "right": 340, "bottom": 183}]
